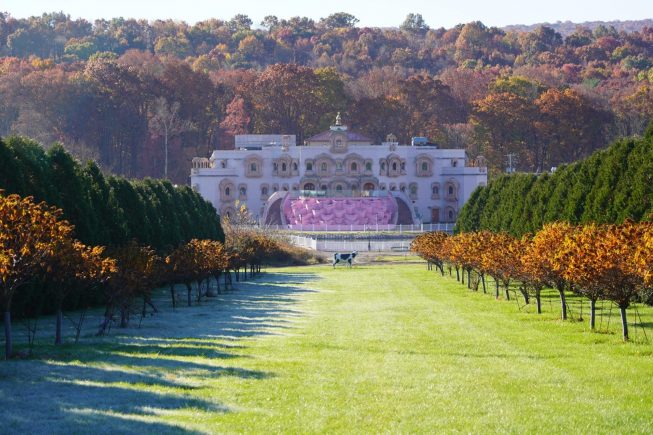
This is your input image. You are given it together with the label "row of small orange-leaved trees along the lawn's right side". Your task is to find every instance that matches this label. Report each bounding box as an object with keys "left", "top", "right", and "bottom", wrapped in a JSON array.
[{"left": 411, "top": 221, "right": 653, "bottom": 340}]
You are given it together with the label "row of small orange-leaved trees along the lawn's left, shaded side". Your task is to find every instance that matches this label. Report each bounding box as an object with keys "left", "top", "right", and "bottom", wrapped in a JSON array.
[{"left": 0, "top": 191, "right": 306, "bottom": 358}]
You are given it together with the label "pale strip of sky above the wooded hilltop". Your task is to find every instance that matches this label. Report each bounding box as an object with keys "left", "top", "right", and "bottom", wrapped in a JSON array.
[{"left": 5, "top": 0, "right": 653, "bottom": 28}]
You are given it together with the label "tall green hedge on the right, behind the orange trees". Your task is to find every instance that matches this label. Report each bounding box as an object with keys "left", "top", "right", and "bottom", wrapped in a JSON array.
[{"left": 456, "top": 124, "right": 653, "bottom": 236}]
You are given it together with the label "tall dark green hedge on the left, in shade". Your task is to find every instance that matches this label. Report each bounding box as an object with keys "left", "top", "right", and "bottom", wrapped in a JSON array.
[{"left": 0, "top": 137, "right": 224, "bottom": 252}]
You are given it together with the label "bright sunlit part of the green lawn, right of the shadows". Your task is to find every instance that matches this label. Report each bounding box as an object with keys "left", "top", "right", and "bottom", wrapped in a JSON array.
[{"left": 178, "top": 265, "right": 653, "bottom": 432}]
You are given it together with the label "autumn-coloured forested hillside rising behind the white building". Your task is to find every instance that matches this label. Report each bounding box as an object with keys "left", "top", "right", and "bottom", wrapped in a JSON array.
[{"left": 0, "top": 13, "right": 653, "bottom": 183}]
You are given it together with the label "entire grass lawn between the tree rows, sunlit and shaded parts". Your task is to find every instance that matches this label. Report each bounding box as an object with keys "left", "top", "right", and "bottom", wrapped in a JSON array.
[{"left": 0, "top": 263, "right": 653, "bottom": 433}]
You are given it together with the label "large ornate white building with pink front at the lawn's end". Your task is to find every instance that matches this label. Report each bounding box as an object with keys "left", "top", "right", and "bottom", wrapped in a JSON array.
[{"left": 191, "top": 116, "right": 487, "bottom": 229}]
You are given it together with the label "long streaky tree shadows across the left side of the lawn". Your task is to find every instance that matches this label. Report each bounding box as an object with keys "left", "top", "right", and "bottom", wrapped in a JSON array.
[{"left": 0, "top": 272, "right": 315, "bottom": 433}]
